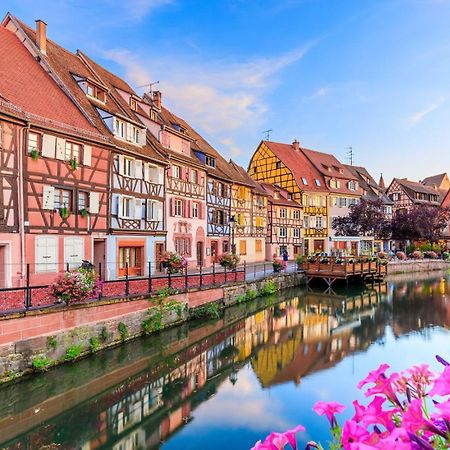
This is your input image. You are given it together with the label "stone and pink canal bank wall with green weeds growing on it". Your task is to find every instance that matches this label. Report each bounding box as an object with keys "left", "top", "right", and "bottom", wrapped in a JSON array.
[{"left": 0, "top": 273, "right": 305, "bottom": 382}]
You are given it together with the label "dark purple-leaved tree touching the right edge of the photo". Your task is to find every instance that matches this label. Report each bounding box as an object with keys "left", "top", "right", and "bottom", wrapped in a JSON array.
[{"left": 392, "top": 205, "right": 450, "bottom": 243}]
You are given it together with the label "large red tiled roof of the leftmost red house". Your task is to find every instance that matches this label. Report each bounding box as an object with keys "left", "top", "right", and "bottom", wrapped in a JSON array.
[{"left": 0, "top": 26, "right": 96, "bottom": 132}]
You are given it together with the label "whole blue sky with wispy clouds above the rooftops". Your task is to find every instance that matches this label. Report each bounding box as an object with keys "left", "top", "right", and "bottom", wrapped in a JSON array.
[{"left": 5, "top": 0, "right": 450, "bottom": 182}]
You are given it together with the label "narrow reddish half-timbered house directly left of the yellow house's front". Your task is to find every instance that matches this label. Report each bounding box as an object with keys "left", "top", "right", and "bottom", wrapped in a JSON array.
[{"left": 260, "top": 183, "right": 302, "bottom": 259}]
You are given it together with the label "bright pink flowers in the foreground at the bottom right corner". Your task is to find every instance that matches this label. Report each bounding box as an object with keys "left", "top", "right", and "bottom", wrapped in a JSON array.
[{"left": 252, "top": 356, "right": 450, "bottom": 450}]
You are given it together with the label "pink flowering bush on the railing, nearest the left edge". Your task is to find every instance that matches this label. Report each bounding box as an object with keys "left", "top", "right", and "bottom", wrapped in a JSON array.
[{"left": 50, "top": 268, "right": 100, "bottom": 305}]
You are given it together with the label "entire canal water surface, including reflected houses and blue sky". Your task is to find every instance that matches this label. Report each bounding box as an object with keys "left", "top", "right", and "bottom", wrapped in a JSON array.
[{"left": 0, "top": 274, "right": 450, "bottom": 450}]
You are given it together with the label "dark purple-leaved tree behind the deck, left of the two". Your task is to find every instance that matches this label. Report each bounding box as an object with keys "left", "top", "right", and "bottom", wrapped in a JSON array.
[{"left": 332, "top": 199, "right": 391, "bottom": 239}]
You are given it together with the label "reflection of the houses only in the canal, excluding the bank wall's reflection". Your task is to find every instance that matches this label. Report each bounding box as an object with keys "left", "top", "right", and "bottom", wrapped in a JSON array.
[{"left": 2, "top": 278, "right": 450, "bottom": 450}]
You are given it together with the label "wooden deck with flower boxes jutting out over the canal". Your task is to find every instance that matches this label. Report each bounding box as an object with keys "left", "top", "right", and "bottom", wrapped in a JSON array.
[{"left": 300, "top": 257, "right": 387, "bottom": 288}]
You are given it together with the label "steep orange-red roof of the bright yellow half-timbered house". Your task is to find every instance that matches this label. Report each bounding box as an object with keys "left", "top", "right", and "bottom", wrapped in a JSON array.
[{"left": 262, "top": 141, "right": 328, "bottom": 192}]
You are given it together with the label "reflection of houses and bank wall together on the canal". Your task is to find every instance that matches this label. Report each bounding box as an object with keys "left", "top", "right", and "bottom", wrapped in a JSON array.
[{"left": 0, "top": 276, "right": 450, "bottom": 450}]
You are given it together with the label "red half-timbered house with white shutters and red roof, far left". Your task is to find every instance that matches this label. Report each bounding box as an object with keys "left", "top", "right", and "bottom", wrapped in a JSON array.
[{"left": 0, "top": 20, "right": 108, "bottom": 283}]
